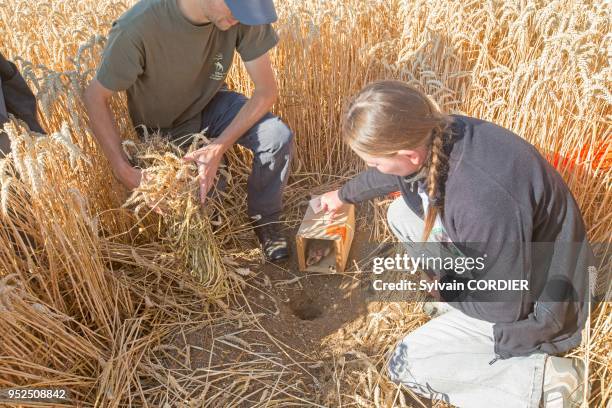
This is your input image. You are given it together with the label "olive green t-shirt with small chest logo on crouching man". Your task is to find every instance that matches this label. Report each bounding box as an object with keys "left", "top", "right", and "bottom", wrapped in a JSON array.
[{"left": 96, "top": 0, "right": 278, "bottom": 136}]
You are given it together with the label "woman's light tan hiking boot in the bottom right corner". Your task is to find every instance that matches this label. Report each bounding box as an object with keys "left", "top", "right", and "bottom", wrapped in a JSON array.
[{"left": 540, "top": 356, "right": 586, "bottom": 408}]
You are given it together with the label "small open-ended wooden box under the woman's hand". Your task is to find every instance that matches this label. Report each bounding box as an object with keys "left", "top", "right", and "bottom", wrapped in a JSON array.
[{"left": 296, "top": 204, "right": 355, "bottom": 273}]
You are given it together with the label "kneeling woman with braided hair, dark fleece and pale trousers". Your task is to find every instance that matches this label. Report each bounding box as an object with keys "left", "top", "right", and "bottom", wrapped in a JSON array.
[{"left": 322, "top": 81, "right": 592, "bottom": 407}]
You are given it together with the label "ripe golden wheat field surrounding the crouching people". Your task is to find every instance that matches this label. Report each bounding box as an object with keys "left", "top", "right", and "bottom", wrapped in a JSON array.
[{"left": 0, "top": 0, "right": 612, "bottom": 407}]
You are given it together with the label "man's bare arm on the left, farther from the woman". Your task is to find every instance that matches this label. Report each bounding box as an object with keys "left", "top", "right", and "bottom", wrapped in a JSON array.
[{"left": 84, "top": 78, "right": 141, "bottom": 190}]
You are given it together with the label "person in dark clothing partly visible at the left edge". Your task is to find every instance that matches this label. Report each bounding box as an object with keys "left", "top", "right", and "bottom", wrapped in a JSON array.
[{"left": 0, "top": 53, "right": 44, "bottom": 159}]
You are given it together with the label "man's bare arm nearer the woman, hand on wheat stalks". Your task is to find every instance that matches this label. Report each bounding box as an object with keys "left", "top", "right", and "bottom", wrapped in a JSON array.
[{"left": 185, "top": 52, "right": 278, "bottom": 203}]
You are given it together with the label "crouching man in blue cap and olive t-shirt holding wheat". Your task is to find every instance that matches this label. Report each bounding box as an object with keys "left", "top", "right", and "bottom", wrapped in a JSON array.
[{"left": 84, "top": 0, "right": 293, "bottom": 261}]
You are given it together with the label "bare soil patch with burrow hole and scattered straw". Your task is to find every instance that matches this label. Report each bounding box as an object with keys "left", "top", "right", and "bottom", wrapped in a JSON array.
[{"left": 166, "top": 229, "right": 430, "bottom": 406}]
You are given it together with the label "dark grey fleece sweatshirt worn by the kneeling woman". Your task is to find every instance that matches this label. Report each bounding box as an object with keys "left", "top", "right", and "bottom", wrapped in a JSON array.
[{"left": 340, "top": 115, "right": 594, "bottom": 358}]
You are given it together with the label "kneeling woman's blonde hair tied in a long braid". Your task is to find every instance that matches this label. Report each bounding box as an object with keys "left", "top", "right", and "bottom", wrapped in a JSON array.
[{"left": 342, "top": 80, "right": 451, "bottom": 241}]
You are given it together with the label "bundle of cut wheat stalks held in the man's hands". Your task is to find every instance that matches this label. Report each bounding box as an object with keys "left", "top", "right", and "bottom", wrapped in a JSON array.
[{"left": 123, "top": 134, "right": 229, "bottom": 299}]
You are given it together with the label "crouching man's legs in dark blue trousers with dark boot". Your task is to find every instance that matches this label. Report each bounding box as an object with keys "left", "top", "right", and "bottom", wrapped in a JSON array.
[{"left": 202, "top": 88, "right": 293, "bottom": 261}]
